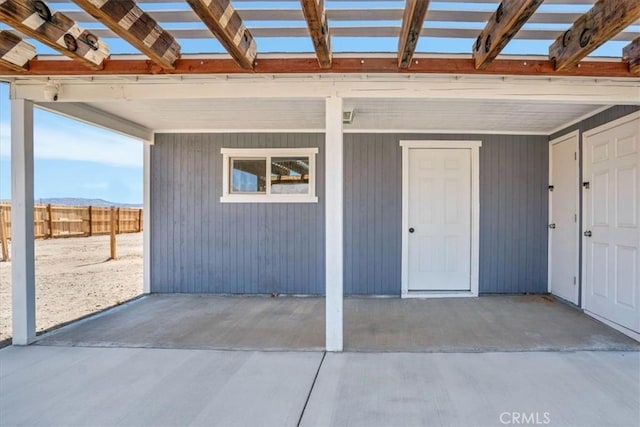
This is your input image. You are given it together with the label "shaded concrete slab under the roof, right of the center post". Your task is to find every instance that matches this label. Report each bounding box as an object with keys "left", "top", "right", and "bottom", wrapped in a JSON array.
[{"left": 344, "top": 295, "right": 640, "bottom": 352}]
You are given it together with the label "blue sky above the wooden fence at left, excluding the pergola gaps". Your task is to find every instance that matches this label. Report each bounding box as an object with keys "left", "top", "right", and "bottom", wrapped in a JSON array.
[{"left": 0, "top": 83, "right": 143, "bottom": 204}]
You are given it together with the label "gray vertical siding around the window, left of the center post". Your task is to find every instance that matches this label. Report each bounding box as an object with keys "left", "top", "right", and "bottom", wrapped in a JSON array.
[{"left": 151, "top": 134, "right": 324, "bottom": 294}]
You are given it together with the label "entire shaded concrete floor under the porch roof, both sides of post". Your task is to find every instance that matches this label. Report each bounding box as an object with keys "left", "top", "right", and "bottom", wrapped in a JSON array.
[{"left": 37, "top": 294, "right": 640, "bottom": 352}]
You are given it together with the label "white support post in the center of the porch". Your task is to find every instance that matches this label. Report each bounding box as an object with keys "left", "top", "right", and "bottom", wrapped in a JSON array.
[{"left": 324, "top": 97, "right": 344, "bottom": 351}]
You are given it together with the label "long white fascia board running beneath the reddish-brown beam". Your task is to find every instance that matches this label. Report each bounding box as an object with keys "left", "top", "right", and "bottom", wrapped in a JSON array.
[{"left": 11, "top": 75, "right": 640, "bottom": 105}]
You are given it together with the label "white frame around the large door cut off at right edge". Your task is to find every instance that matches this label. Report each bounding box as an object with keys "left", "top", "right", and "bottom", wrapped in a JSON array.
[{"left": 580, "top": 111, "right": 640, "bottom": 341}]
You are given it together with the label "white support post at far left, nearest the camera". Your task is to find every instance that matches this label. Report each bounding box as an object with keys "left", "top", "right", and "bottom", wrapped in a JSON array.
[{"left": 11, "top": 99, "right": 36, "bottom": 345}]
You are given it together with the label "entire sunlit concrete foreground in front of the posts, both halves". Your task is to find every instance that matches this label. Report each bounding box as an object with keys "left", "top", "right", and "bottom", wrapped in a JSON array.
[{"left": 0, "top": 346, "right": 640, "bottom": 427}]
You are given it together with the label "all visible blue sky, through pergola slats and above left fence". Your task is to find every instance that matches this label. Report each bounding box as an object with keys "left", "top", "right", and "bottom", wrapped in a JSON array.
[{"left": 0, "top": 1, "right": 638, "bottom": 204}]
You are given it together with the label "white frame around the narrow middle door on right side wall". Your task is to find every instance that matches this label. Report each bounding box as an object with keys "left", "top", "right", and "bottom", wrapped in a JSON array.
[{"left": 547, "top": 130, "right": 582, "bottom": 304}]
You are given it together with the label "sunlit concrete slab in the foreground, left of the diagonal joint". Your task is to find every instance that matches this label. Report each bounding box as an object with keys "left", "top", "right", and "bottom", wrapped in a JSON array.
[{"left": 0, "top": 346, "right": 322, "bottom": 426}]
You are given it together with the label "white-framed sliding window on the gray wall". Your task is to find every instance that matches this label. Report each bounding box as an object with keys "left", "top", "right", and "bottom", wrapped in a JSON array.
[{"left": 220, "top": 148, "right": 318, "bottom": 203}]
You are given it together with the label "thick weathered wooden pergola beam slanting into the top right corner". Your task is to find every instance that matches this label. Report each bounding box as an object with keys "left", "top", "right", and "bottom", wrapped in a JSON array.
[{"left": 549, "top": 0, "right": 640, "bottom": 70}]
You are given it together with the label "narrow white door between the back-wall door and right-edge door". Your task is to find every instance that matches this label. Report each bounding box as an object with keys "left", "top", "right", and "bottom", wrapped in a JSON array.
[{"left": 549, "top": 132, "right": 580, "bottom": 304}]
